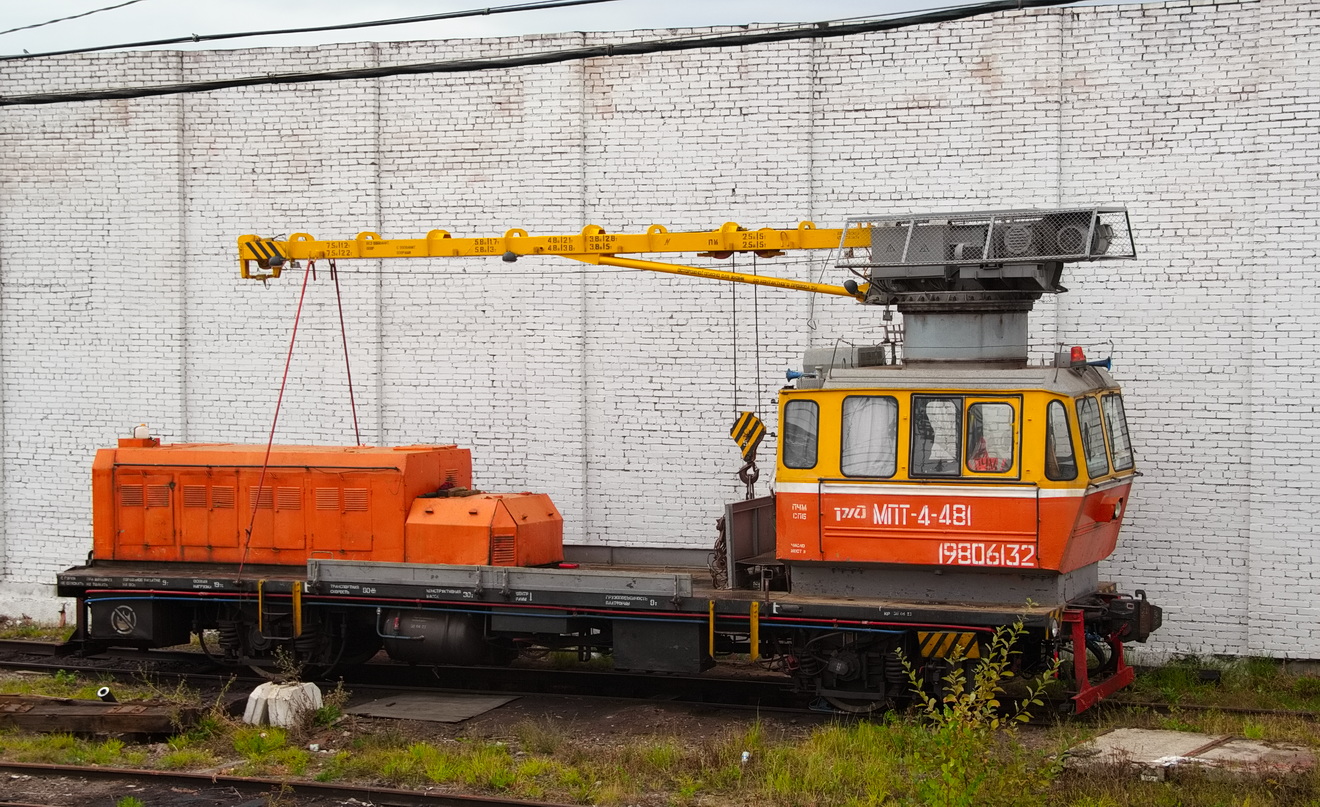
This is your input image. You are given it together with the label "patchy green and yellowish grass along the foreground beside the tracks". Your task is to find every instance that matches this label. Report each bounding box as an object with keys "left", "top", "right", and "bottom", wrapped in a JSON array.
[{"left": 0, "top": 659, "right": 1320, "bottom": 807}]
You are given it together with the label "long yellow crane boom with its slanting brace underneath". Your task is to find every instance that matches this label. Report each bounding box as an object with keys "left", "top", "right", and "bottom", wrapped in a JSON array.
[{"left": 238, "top": 222, "right": 870, "bottom": 300}]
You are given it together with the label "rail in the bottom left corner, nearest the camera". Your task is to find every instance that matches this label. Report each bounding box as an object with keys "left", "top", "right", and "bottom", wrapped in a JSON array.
[{"left": 0, "top": 762, "right": 556, "bottom": 807}]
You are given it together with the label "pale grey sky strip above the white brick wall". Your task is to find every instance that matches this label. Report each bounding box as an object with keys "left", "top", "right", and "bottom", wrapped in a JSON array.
[{"left": 0, "top": 0, "right": 1156, "bottom": 54}]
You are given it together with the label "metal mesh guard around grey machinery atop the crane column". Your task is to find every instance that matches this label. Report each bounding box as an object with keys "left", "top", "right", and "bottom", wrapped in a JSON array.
[{"left": 838, "top": 207, "right": 1137, "bottom": 267}]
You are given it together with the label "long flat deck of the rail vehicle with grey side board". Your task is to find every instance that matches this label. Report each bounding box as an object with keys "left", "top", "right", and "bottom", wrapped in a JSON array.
[{"left": 58, "top": 559, "right": 1067, "bottom": 629}]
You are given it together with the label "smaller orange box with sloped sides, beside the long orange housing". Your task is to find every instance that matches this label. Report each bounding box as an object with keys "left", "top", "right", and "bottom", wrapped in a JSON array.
[{"left": 404, "top": 493, "right": 564, "bottom": 567}]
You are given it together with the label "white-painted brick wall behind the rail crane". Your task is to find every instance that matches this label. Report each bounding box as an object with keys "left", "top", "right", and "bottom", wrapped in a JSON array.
[{"left": 0, "top": 0, "right": 1320, "bottom": 658}]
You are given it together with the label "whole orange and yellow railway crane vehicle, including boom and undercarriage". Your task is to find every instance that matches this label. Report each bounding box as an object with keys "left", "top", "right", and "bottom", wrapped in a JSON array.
[{"left": 58, "top": 207, "right": 1162, "bottom": 712}]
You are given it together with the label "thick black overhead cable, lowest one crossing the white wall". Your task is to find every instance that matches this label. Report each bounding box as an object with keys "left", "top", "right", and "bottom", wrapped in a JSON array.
[{"left": 0, "top": 0, "right": 1081, "bottom": 107}]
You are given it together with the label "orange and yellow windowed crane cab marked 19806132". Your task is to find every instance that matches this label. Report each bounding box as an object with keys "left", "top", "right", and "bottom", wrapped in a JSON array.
[{"left": 776, "top": 367, "right": 1135, "bottom": 573}]
